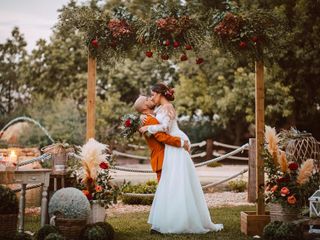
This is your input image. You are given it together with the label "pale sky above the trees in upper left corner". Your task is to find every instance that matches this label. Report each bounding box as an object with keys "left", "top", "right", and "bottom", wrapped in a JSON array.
[{"left": 0, "top": 0, "right": 77, "bottom": 52}]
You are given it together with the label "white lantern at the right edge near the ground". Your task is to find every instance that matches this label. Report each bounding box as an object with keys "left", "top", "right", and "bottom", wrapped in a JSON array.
[{"left": 309, "top": 189, "right": 320, "bottom": 234}]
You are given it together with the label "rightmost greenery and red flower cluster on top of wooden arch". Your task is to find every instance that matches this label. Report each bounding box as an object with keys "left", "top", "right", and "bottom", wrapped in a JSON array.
[{"left": 208, "top": 1, "right": 285, "bottom": 60}]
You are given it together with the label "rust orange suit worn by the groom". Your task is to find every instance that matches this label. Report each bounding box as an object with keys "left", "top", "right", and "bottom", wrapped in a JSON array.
[{"left": 143, "top": 115, "right": 181, "bottom": 181}]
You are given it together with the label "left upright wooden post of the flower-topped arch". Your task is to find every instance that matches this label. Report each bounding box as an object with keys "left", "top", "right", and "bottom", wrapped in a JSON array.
[{"left": 86, "top": 54, "right": 97, "bottom": 141}]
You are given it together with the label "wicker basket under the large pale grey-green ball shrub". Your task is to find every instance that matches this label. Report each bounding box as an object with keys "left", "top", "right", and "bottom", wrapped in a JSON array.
[{"left": 55, "top": 217, "right": 87, "bottom": 240}]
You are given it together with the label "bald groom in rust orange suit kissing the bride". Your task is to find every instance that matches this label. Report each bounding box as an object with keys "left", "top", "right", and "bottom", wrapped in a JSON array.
[{"left": 134, "top": 96, "right": 190, "bottom": 182}]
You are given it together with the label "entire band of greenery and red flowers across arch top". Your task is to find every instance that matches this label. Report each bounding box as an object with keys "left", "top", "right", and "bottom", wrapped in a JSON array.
[{"left": 58, "top": 0, "right": 283, "bottom": 64}]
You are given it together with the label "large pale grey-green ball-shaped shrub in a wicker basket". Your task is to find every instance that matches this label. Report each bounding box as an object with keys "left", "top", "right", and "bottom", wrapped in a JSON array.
[{"left": 49, "top": 188, "right": 90, "bottom": 219}]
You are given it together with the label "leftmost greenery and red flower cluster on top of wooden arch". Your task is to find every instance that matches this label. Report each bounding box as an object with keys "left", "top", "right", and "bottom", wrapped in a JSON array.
[{"left": 58, "top": 3, "right": 136, "bottom": 62}]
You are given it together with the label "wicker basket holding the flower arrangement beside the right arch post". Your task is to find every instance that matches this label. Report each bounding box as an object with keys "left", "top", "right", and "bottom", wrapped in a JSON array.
[{"left": 269, "top": 203, "right": 301, "bottom": 222}]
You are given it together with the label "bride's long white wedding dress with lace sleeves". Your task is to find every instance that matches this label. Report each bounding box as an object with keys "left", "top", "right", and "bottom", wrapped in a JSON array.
[{"left": 148, "top": 104, "right": 223, "bottom": 233}]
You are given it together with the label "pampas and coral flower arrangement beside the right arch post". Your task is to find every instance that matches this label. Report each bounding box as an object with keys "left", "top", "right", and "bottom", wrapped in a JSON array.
[{"left": 264, "top": 126, "right": 319, "bottom": 208}]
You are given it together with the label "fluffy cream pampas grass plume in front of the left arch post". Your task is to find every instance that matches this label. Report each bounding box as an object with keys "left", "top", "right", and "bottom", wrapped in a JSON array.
[{"left": 79, "top": 138, "right": 108, "bottom": 183}]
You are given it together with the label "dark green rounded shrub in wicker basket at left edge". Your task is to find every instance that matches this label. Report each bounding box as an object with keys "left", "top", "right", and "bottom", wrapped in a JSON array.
[{"left": 0, "top": 185, "right": 19, "bottom": 235}]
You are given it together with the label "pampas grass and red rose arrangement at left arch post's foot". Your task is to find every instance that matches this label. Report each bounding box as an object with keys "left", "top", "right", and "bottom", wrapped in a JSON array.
[{"left": 76, "top": 138, "right": 119, "bottom": 208}]
